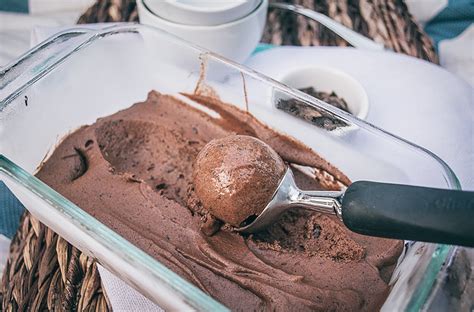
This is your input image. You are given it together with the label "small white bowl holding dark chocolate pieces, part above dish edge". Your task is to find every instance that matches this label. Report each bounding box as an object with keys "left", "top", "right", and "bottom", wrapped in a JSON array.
[{"left": 278, "top": 67, "right": 369, "bottom": 119}]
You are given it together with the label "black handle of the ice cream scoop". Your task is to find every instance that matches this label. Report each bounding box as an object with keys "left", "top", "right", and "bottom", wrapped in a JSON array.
[{"left": 342, "top": 181, "right": 474, "bottom": 247}]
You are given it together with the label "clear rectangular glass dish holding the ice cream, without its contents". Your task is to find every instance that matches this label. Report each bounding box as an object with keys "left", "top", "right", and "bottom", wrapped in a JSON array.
[{"left": 0, "top": 24, "right": 460, "bottom": 311}]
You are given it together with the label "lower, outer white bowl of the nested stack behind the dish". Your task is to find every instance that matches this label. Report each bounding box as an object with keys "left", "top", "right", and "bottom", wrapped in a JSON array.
[{"left": 137, "top": 0, "right": 268, "bottom": 63}]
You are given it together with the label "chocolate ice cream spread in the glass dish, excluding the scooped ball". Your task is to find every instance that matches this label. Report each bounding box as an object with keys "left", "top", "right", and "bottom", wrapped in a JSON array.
[{"left": 37, "top": 91, "right": 403, "bottom": 311}]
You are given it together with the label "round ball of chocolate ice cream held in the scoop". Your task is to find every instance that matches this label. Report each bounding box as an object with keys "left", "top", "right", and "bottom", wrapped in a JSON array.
[{"left": 193, "top": 135, "right": 286, "bottom": 227}]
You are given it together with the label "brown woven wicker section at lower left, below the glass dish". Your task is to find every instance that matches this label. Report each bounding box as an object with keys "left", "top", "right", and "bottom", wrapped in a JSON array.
[{"left": 1, "top": 212, "right": 110, "bottom": 311}]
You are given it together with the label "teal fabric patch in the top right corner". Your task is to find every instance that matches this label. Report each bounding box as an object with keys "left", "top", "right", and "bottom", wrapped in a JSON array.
[{"left": 425, "top": 0, "right": 474, "bottom": 46}]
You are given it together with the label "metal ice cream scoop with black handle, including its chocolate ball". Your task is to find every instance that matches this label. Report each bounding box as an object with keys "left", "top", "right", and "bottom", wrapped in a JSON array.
[{"left": 194, "top": 136, "right": 474, "bottom": 247}]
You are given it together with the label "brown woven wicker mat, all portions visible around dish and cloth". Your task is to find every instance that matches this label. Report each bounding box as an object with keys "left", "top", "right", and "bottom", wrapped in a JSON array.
[{"left": 0, "top": 0, "right": 438, "bottom": 311}]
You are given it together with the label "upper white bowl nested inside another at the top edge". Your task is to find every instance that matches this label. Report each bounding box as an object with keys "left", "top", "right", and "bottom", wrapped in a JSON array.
[{"left": 143, "top": 0, "right": 262, "bottom": 26}]
